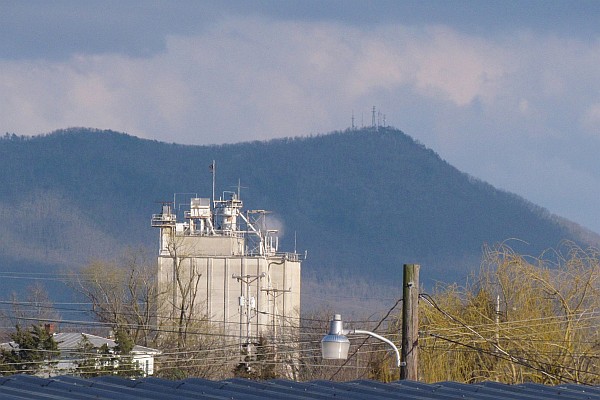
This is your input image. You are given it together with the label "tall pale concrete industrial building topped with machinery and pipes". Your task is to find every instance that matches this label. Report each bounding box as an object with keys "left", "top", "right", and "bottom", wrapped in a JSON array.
[{"left": 152, "top": 184, "right": 301, "bottom": 350}]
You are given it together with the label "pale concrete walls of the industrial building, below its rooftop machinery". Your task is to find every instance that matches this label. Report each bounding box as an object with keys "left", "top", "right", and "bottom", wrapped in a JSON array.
[{"left": 158, "top": 252, "right": 301, "bottom": 341}]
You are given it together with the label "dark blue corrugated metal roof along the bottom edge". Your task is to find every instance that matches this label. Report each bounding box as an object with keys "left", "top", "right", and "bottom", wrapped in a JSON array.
[{"left": 0, "top": 375, "right": 600, "bottom": 400}]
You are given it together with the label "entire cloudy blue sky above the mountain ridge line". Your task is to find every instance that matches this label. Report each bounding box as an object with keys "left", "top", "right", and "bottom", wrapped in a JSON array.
[{"left": 0, "top": 0, "right": 600, "bottom": 233}]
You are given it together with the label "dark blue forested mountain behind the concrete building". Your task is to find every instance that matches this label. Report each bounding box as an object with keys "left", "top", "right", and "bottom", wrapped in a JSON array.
[{"left": 0, "top": 128, "right": 597, "bottom": 310}]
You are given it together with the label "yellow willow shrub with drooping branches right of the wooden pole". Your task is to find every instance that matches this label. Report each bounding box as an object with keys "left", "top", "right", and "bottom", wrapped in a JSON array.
[{"left": 419, "top": 243, "right": 600, "bottom": 384}]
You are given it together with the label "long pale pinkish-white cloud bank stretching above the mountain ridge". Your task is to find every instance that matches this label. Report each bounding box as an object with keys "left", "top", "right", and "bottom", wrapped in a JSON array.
[{"left": 0, "top": 18, "right": 596, "bottom": 143}]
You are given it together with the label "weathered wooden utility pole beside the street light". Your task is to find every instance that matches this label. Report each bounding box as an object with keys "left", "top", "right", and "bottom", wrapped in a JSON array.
[{"left": 400, "top": 264, "right": 420, "bottom": 381}]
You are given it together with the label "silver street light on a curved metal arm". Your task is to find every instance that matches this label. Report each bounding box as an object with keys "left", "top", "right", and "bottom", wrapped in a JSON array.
[{"left": 321, "top": 314, "right": 403, "bottom": 367}]
